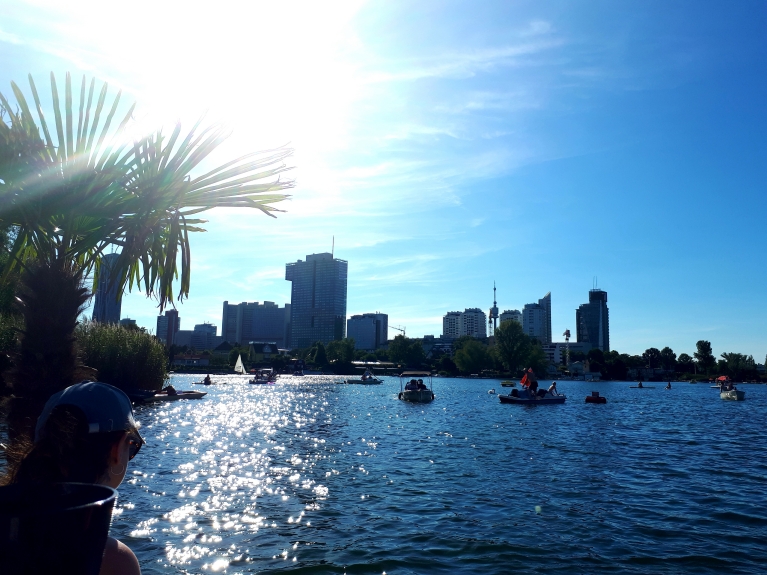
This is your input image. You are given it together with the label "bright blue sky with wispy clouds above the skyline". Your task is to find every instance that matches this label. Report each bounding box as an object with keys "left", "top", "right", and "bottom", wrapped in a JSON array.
[{"left": 0, "top": 0, "right": 767, "bottom": 362}]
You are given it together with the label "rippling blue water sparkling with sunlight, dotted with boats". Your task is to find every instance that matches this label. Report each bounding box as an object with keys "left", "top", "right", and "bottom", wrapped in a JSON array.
[{"left": 112, "top": 376, "right": 767, "bottom": 574}]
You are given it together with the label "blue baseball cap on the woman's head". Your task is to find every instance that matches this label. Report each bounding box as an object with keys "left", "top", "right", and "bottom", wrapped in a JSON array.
[{"left": 35, "top": 381, "right": 138, "bottom": 441}]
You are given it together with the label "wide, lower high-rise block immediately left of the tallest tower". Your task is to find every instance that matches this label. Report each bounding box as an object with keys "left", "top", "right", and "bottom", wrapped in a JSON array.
[{"left": 221, "top": 301, "right": 291, "bottom": 348}]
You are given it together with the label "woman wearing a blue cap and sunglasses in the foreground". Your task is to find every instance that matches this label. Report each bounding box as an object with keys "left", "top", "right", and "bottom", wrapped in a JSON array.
[{"left": 5, "top": 382, "right": 144, "bottom": 575}]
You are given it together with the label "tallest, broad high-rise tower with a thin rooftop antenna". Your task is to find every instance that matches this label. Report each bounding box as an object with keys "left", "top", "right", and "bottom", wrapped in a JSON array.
[{"left": 285, "top": 253, "right": 349, "bottom": 348}]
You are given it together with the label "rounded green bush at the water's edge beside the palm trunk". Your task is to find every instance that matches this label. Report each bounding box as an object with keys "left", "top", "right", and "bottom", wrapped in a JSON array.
[{"left": 75, "top": 322, "right": 168, "bottom": 390}]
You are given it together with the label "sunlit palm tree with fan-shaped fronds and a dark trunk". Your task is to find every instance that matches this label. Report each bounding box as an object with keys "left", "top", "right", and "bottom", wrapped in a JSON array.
[{"left": 0, "top": 73, "right": 293, "bottom": 404}]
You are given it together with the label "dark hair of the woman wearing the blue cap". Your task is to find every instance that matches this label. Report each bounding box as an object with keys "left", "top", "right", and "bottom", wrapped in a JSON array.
[{"left": 4, "top": 405, "right": 137, "bottom": 484}]
